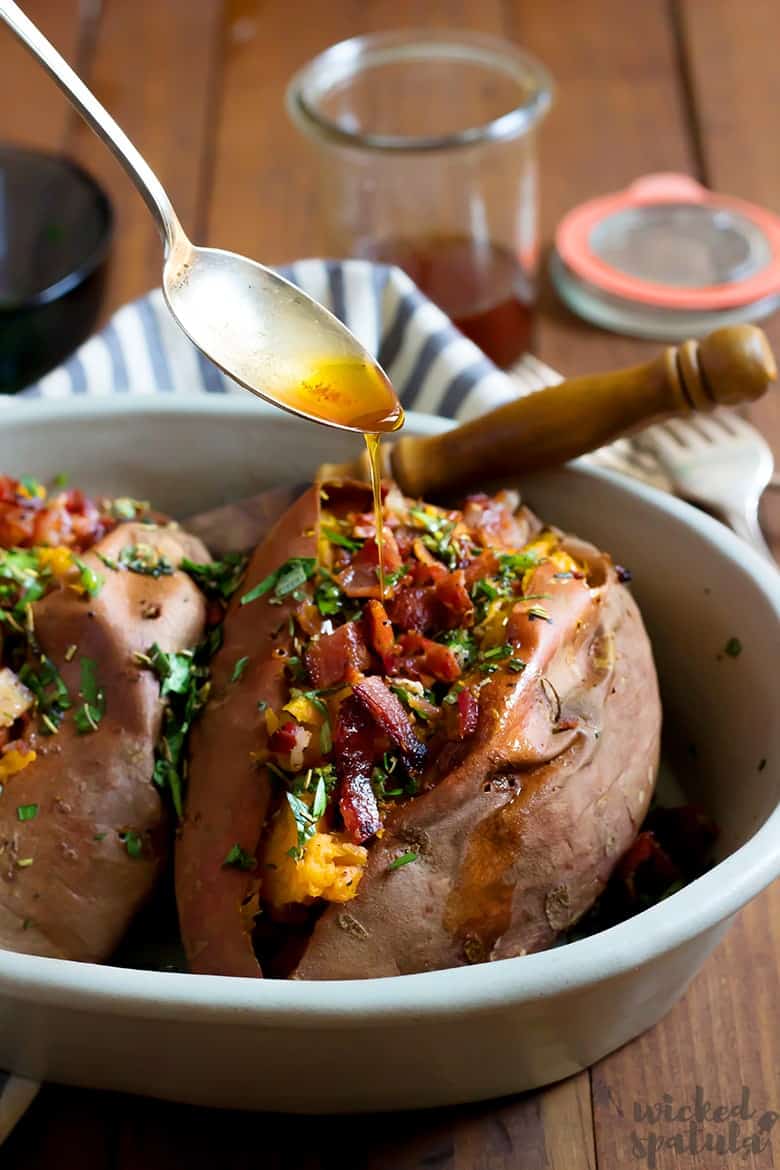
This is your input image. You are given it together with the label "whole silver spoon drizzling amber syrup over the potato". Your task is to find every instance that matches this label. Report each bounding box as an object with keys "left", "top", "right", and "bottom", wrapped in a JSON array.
[{"left": 0, "top": 0, "right": 403, "bottom": 432}]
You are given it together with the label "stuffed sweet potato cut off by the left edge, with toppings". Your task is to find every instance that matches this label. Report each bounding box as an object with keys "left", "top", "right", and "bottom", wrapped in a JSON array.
[{"left": 0, "top": 512, "right": 209, "bottom": 962}]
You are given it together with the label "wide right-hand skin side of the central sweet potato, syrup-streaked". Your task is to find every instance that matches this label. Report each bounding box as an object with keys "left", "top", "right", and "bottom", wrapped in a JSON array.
[{"left": 292, "top": 542, "right": 661, "bottom": 979}]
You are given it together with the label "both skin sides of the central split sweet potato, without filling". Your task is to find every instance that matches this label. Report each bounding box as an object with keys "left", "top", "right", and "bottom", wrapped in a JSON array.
[{"left": 177, "top": 489, "right": 661, "bottom": 979}]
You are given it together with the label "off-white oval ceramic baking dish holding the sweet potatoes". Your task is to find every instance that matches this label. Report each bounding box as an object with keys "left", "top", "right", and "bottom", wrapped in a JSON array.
[{"left": 0, "top": 397, "right": 780, "bottom": 1112}]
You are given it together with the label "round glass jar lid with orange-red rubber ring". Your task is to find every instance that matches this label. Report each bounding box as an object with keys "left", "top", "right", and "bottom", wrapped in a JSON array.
[{"left": 551, "top": 174, "right": 780, "bottom": 339}]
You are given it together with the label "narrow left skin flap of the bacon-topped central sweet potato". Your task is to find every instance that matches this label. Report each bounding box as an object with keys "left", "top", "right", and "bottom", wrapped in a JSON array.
[{"left": 175, "top": 487, "right": 319, "bottom": 977}]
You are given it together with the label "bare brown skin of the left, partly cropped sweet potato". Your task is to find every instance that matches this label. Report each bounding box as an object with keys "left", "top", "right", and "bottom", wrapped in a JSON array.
[{"left": 0, "top": 523, "right": 209, "bottom": 962}]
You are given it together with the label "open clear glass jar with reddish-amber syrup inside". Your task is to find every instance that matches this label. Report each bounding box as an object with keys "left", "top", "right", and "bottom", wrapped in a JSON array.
[{"left": 288, "top": 29, "right": 552, "bottom": 367}]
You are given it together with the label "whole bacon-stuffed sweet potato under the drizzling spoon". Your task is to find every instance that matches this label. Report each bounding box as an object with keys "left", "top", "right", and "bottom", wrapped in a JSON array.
[{"left": 177, "top": 483, "right": 661, "bottom": 979}]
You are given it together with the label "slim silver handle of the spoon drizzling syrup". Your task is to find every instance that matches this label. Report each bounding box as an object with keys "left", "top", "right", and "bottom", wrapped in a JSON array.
[{"left": 0, "top": 0, "right": 184, "bottom": 255}]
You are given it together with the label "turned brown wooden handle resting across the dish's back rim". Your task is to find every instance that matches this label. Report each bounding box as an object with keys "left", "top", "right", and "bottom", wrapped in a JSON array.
[{"left": 388, "top": 325, "right": 778, "bottom": 497}]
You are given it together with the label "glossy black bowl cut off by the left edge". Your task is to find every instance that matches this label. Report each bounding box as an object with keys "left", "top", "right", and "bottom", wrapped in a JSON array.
[{"left": 0, "top": 145, "right": 113, "bottom": 394}]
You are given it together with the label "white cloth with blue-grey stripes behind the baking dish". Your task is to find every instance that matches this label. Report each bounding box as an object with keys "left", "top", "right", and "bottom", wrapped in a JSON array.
[{"left": 0, "top": 260, "right": 668, "bottom": 1143}]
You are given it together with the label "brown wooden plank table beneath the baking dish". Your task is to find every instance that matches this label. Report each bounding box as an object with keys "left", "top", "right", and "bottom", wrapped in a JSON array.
[{"left": 0, "top": 0, "right": 780, "bottom": 1170}]
